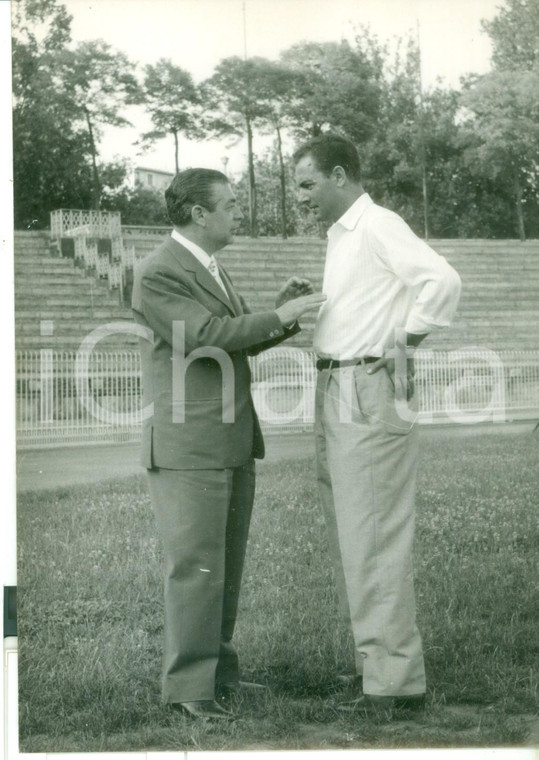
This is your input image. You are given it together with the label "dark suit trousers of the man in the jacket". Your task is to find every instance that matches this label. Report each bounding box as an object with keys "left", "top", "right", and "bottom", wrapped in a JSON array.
[{"left": 148, "top": 460, "right": 255, "bottom": 702}]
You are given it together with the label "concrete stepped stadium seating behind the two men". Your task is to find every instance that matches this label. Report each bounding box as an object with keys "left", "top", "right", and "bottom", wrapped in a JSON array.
[{"left": 15, "top": 228, "right": 539, "bottom": 350}]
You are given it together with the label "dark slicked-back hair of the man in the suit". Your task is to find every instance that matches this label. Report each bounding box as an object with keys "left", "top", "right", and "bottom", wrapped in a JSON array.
[{"left": 165, "top": 169, "right": 228, "bottom": 227}]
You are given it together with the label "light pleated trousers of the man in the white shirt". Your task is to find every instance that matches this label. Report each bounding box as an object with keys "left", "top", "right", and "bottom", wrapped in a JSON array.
[{"left": 315, "top": 365, "right": 426, "bottom": 696}]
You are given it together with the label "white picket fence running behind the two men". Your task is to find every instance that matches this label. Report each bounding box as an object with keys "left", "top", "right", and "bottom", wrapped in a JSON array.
[{"left": 17, "top": 348, "right": 539, "bottom": 448}]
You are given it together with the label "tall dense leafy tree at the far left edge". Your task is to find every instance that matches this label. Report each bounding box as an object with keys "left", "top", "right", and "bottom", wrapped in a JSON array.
[{"left": 12, "top": 0, "right": 96, "bottom": 228}]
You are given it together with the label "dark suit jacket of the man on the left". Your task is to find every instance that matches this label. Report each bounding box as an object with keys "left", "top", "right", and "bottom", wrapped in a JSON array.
[{"left": 132, "top": 238, "right": 299, "bottom": 470}]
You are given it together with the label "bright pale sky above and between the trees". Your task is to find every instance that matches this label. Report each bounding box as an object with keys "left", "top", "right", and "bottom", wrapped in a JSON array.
[{"left": 63, "top": 0, "right": 502, "bottom": 173}]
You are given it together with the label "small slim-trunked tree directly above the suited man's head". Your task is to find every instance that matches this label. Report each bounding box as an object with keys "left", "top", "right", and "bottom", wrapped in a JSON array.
[{"left": 142, "top": 58, "right": 203, "bottom": 173}]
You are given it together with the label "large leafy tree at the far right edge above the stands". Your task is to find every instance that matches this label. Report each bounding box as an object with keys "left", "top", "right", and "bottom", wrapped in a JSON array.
[{"left": 462, "top": 0, "right": 539, "bottom": 240}]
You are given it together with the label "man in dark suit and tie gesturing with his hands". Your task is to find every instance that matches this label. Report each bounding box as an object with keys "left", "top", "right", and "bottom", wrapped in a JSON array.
[{"left": 133, "top": 169, "right": 324, "bottom": 719}]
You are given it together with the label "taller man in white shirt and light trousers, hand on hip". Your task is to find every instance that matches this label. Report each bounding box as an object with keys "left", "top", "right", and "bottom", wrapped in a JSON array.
[{"left": 294, "top": 134, "right": 460, "bottom": 712}]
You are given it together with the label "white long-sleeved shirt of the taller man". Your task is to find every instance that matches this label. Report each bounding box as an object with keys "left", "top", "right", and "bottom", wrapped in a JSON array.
[{"left": 314, "top": 193, "right": 460, "bottom": 360}]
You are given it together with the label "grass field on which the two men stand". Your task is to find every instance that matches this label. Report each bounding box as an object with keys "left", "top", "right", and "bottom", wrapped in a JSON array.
[{"left": 18, "top": 433, "right": 539, "bottom": 752}]
